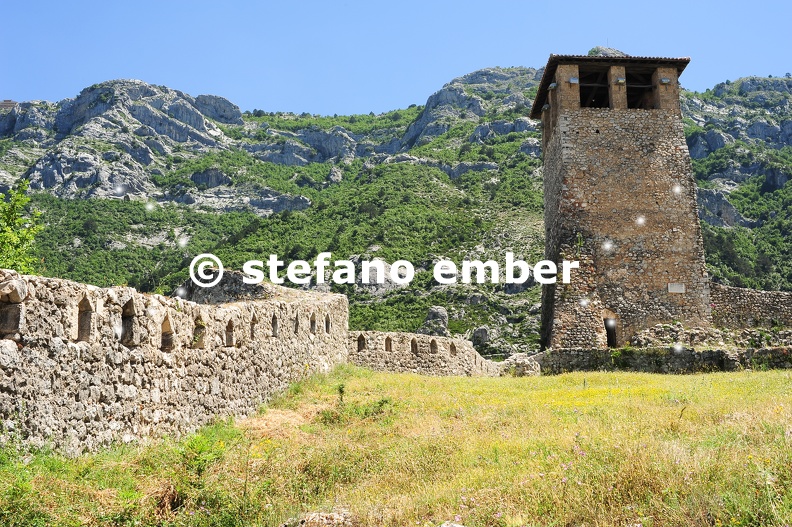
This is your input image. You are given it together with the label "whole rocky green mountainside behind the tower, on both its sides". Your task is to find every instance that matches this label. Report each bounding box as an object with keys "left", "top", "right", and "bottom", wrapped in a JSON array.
[{"left": 0, "top": 60, "right": 792, "bottom": 353}]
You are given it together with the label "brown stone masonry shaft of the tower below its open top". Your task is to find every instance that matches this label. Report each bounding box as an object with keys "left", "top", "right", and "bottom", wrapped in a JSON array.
[{"left": 543, "top": 108, "right": 710, "bottom": 347}]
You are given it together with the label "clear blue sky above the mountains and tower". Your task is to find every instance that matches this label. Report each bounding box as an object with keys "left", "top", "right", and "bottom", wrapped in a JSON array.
[{"left": 6, "top": 0, "right": 792, "bottom": 115}]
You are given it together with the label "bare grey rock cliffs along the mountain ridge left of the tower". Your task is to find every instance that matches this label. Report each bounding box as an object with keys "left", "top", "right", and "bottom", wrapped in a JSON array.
[{"left": 0, "top": 68, "right": 538, "bottom": 215}]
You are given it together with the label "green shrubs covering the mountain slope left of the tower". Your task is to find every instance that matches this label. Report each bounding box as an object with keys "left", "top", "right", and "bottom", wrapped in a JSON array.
[{"left": 33, "top": 153, "right": 542, "bottom": 344}]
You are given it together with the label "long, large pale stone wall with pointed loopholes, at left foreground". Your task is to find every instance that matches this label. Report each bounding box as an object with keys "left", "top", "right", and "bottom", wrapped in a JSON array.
[{"left": 0, "top": 271, "right": 348, "bottom": 453}]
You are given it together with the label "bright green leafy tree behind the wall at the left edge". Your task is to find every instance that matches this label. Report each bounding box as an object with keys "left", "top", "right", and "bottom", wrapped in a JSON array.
[{"left": 0, "top": 179, "right": 43, "bottom": 273}]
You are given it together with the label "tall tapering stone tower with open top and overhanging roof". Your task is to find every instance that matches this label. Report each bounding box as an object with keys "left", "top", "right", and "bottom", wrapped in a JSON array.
[{"left": 531, "top": 55, "right": 710, "bottom": 348}]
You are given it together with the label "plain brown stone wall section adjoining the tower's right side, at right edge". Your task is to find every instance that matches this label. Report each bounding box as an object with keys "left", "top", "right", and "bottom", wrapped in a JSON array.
[{"left": 710, "top": 283, "right": 792, "bottom": 329}]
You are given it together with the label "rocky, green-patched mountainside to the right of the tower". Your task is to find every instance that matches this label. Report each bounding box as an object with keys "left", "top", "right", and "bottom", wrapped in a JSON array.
[{"left": 683, "top": 77, "right": 792, "bottom": 291}]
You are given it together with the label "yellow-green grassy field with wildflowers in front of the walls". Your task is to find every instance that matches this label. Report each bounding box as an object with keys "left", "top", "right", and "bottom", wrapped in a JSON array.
[{"left": 0, "top": 367, "right": 792, "bottom": 527}]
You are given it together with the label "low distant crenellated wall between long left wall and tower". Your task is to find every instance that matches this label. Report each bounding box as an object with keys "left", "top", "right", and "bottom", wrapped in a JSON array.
[{"left": 349, "top": 331, "right": 500, "bottom": 376}]
